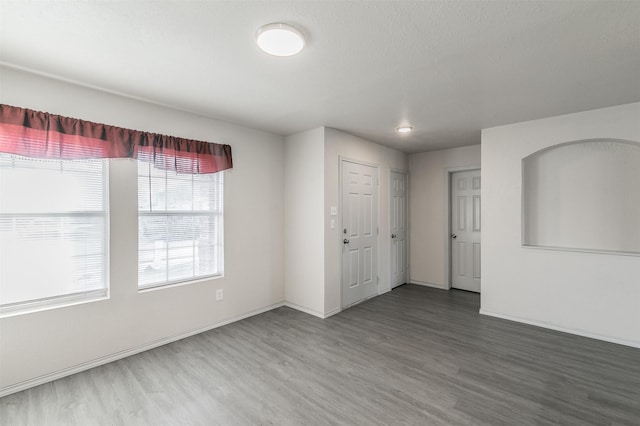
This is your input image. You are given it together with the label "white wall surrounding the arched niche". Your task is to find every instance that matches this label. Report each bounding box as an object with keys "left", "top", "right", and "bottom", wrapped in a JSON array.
[{"left": 481, "top": 103, "right": 640, "bottom": 347}]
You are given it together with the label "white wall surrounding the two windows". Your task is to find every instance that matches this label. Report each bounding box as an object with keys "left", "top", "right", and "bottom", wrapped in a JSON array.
[{"left": 0, "top": 68, "right": 284, "bottom": 394}]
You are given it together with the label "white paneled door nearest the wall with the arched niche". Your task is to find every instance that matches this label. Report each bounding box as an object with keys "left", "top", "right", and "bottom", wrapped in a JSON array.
[{"left": 450, "top": 170, "right": 481, "bottom": 293}]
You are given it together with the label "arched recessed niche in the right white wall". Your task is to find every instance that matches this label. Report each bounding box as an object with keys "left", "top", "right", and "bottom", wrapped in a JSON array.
[{"left": 522, "top": 139, "right": 640, "bottom": 256}]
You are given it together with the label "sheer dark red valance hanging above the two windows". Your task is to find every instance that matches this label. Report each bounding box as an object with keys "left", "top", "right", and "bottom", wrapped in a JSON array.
[{"left": 0, "top": 104, "right": 233, "bottom": 174}]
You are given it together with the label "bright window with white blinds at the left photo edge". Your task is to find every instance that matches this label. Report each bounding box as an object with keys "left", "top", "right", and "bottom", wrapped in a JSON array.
[{"left": 0, "top": 153, "right": 108, "bottom": 314}]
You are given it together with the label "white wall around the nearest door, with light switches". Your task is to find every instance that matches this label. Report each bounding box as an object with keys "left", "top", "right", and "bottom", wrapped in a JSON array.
[{"left": 324, "top": 128, "right": 409, "bottom": 315}]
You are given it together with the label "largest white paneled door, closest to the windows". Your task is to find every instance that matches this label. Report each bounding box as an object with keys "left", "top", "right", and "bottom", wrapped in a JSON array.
[{"left": 341, "top": 160, "right": 378, "bottom": 307}]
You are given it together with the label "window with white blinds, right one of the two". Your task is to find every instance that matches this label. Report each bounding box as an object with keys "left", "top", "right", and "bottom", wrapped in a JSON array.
[{"left": 138, "top": 162, "right": 223, "bottom": 289}]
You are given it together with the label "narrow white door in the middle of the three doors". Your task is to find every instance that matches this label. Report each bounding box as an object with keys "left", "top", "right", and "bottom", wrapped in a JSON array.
[{"left": 390, "top": 172, "right": 408, "bottom": 288}]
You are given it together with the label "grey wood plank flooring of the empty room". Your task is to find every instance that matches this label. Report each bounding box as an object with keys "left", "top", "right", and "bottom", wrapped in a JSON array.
[{"left": 0, "top": 285, "right": 640, "bottom": 426}]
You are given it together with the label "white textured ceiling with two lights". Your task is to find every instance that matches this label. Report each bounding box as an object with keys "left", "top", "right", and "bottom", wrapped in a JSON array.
[{"left": 0, "top": 0, "right": 640, "bottom": 152}]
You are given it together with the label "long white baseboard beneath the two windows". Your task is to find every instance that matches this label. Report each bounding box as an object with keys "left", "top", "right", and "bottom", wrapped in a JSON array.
[{"left": 0, "top": 302, "right": 284, "bottom": 398}]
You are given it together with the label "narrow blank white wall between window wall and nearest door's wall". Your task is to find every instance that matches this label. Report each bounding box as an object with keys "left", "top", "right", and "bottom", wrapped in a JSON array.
[{"left": 284, "top": 127, "right": 324, "bottom": 317}]
